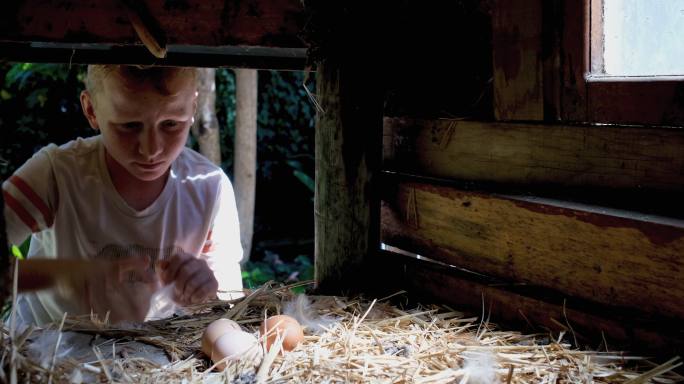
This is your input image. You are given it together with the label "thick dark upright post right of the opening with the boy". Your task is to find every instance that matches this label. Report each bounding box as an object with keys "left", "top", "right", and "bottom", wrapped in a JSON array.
[{"left": 314, "top": 59, "right": 383, "bottom": 293}]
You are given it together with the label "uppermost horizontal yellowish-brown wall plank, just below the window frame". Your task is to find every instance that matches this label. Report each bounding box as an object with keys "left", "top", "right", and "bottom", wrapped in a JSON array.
[{"left": 383, "top": 118, "right": 684, "bottom": 191}]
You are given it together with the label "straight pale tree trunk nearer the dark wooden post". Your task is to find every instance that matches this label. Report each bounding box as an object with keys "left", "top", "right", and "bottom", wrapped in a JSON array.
[{"left": 233, "top": 69, "right": 257, "bottom": 263}]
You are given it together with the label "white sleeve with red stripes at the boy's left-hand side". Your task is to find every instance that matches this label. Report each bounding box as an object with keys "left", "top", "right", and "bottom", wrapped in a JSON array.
[{"left": 2, "top": 149, "right": 58, "bottom": 244}]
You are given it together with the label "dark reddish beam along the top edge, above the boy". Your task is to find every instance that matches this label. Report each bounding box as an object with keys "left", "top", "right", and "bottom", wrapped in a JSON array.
[{"left": 0, "top": 0, "right": 304, "bottom": 48}]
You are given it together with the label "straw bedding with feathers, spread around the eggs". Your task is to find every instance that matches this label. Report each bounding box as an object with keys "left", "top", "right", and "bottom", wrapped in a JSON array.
[{"left": 0, "top": 284, "right": 684, "bottom": 384}]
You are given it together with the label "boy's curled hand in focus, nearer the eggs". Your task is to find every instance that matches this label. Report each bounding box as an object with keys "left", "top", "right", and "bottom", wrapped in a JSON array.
[{"left": 160, "top": 254, "right": 218, "bottom": 305}]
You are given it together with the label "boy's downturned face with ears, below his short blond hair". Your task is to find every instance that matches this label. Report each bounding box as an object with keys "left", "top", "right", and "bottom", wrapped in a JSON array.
[{"left": 81, "top": 73, "right": 197, "bottom": 181}]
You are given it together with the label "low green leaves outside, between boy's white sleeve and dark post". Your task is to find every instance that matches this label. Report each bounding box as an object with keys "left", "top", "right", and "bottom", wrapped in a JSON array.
[{"left": 242, "top": 252, "right": 314, "bottom": 293}]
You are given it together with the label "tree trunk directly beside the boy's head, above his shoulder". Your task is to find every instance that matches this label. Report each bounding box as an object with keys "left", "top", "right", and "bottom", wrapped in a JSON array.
[{"left": 192, "top": 68, "right": 221, "bottom": 166}]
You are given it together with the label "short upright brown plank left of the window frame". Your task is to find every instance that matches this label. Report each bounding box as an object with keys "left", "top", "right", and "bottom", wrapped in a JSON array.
[{"left": 492, "top": 0, "right": 544, "bottom": 120}]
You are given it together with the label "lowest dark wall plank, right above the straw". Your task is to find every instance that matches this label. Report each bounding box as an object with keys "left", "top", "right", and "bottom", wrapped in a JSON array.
[{"left": 376, "top": 253, "right": 684, "bottom": 357}]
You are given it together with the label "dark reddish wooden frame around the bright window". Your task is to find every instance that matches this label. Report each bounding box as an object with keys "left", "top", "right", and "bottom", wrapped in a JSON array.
[{"left": 560, "top": 0, "right": 684, "bottom": 127}]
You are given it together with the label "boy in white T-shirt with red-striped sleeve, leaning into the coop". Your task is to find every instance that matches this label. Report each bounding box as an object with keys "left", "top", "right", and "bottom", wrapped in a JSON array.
[{"left": 3, "top": 65, "right": 242, "bottom": 324}]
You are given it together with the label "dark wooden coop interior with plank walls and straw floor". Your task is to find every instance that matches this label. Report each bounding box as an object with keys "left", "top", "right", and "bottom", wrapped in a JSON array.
[{"left": 0, "top": 0, "right": 684, "bottom": 383}]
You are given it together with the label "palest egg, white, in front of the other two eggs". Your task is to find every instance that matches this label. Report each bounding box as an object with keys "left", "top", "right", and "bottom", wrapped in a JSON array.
[{"left": 211, "top": 329, "right": 263, "bottom": 370}]
